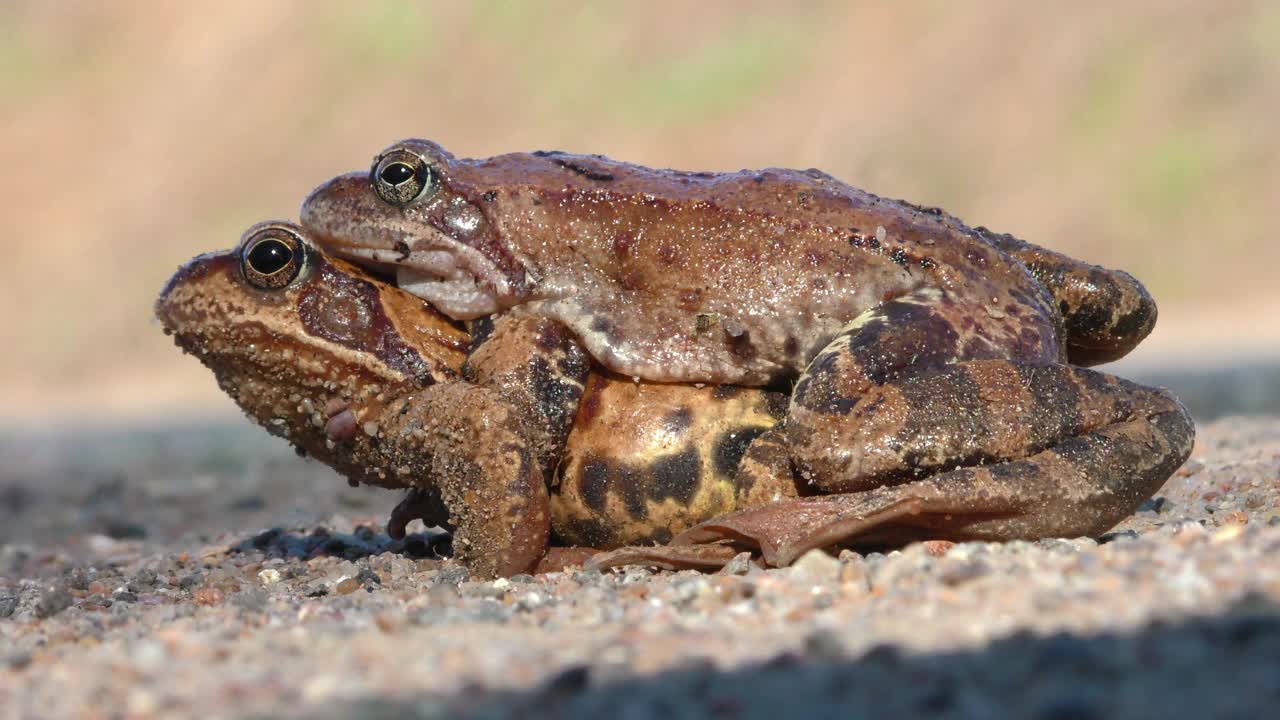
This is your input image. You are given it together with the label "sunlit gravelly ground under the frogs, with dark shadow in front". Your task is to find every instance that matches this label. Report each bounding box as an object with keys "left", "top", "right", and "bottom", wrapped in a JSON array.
[{"left": 0, "top": 418, "right": 1280, "bottom": 719}]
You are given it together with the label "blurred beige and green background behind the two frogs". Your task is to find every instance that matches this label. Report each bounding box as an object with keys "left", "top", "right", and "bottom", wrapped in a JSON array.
[{"left": 0, "top": 0, "right": 1280, "bottom": 427}]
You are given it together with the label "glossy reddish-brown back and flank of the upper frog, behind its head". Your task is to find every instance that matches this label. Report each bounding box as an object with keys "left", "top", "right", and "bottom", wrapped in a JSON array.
[{"left": 475, "top": 152, "right": 1053, "bottom": 384}]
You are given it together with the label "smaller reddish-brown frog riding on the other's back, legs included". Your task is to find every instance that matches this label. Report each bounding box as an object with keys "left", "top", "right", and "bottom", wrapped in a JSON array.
[{"left": 294, "top": 140, "right": 1194, "bottom": 564}]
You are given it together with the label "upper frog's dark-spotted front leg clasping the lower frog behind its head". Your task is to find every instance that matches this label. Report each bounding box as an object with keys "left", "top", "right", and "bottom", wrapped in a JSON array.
[{"left": 462, "top": 315, "right": 589, "bottom": 471}]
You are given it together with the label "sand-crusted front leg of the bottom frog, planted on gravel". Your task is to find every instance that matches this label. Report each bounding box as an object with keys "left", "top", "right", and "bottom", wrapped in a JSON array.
[{"left": 379, "top": 383, "right": 550, "bottom": 578}]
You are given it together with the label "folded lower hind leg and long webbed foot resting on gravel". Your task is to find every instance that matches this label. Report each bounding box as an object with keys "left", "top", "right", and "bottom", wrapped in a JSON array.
[{"left": 671, "top": 360, "right": 1194, "bottom": 566}]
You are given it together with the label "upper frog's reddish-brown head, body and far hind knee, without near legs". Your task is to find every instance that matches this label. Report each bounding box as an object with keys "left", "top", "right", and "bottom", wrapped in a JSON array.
[{"left": 302, "top": 140, "right": 1156, "bottom": 386}]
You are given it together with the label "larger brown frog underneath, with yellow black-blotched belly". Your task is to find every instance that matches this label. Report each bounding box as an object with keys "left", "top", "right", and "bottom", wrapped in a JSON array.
[{"left": 156, "top": 223, "right": 796, "bottom": 577}]
